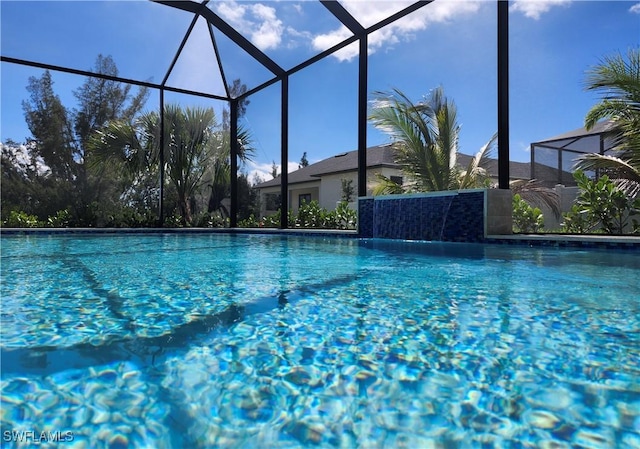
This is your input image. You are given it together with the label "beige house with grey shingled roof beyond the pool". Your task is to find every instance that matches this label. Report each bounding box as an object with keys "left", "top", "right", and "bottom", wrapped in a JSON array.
[{"left": 256, "top": 144, "right": 531, "bottom": 216}]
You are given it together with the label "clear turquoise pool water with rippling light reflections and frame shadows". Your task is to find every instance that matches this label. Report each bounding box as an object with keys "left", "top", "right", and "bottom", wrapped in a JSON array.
[{"left": 0, "top": 234, "right": 640, "bottom": 448}]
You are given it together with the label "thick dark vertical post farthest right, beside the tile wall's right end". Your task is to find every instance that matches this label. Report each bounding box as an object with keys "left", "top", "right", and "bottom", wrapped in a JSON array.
[{"left": 498, "top": 0, "right": 509, "bottom": 189}]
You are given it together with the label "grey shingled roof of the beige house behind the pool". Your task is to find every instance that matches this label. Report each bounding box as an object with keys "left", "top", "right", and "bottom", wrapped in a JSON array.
[{"left": 256, "top": 144, "right": 531, "bottom": 188}]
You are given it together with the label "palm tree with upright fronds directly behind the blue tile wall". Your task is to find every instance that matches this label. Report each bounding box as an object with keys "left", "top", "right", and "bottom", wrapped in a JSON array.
[{"left": 369, "top": 87, "right": 496, "bottom": 194}]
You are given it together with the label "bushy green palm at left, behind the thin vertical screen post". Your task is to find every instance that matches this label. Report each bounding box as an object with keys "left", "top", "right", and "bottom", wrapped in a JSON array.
[{"left": 89, "top": 105, "right": 224, "bottom": 224}]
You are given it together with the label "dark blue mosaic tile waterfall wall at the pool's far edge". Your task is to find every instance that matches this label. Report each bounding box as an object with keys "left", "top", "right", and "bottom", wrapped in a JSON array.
[{"left": 358, "top": 191, "right": 484, "bottom": 242}]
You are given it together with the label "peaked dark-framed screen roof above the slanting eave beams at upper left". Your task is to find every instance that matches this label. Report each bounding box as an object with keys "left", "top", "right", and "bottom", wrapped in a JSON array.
[{"left": 1, "top": 0, "right": 430, "bottom": 97}]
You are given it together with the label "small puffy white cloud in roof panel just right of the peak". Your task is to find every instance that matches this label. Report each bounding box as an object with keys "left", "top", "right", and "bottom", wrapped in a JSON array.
[{"left": 215, "top": 1, "right": 284, "bottom": 50}]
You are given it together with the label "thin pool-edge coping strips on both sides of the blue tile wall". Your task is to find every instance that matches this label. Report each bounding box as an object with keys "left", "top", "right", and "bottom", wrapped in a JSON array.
[{"left": 0, "top": 228, "right": 640, "bottom": 250}]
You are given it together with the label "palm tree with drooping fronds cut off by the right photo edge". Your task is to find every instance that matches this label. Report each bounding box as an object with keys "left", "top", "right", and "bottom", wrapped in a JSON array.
[{"left": 575, "top": 48, "right": 640, "bottom": 197}]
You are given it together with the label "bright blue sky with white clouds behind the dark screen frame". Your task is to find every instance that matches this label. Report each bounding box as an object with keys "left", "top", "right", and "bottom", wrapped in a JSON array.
[{"left": 0, "top": 0, "right": 640, "bottom": 180}]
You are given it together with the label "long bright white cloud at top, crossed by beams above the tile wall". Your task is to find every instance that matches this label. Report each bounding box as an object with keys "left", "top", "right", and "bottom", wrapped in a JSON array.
[{"left": 312, "top": 1, "right": 482, "bottom": 61}]
